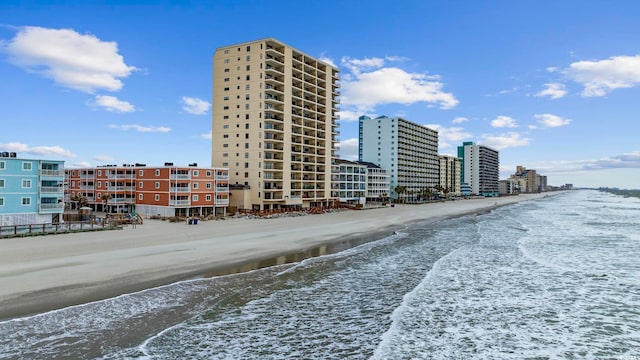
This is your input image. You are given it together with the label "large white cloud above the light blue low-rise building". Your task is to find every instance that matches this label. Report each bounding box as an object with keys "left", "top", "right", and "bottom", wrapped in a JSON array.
[{"left": 4, "top": 26, "right": 136, "bottom": 93}]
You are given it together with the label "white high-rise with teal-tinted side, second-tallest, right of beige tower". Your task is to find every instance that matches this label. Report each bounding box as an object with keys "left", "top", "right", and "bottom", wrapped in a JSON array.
[{"left": 358, "top": 116, "right": 440, "bottom": 199}]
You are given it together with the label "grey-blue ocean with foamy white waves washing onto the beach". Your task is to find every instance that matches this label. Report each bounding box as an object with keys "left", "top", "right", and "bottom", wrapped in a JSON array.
[{"left": 0, "top": 190, "right": 640, "bottom": 360}]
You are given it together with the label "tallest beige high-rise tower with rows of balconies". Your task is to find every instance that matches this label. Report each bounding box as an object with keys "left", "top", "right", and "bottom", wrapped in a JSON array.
[{"left": 211, "top": 38, "right": 340, "bottom": 210}]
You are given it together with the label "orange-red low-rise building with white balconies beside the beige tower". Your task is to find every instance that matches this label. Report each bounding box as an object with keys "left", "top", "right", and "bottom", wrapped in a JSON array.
[{"left": 65, "top": 163, "right": 229, "bottom": 217}]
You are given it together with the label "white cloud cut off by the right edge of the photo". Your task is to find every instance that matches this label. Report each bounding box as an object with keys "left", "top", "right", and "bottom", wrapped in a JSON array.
[{"left": 566, "top": 55, "right": 640, "bottom": 97}]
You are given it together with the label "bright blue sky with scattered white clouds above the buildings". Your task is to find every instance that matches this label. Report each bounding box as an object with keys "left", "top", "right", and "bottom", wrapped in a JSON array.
[{"left": 0, "top": 0, "right": 640, "bottom": 188}]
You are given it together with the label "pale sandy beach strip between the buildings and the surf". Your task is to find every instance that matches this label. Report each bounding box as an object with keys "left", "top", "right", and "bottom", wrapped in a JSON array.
[{"left": 0, "top": 193, "right": 550, "bottom": 320}]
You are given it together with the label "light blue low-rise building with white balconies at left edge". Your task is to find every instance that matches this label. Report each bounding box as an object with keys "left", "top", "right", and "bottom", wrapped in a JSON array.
[{"left": 0, "top": 152, "right": 64, "bottom": 226}]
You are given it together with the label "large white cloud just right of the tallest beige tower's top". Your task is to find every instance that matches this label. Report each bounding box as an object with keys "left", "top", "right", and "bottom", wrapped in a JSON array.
[{"left": 341, "top": 56, "right": 458, "bottom": 114}]
